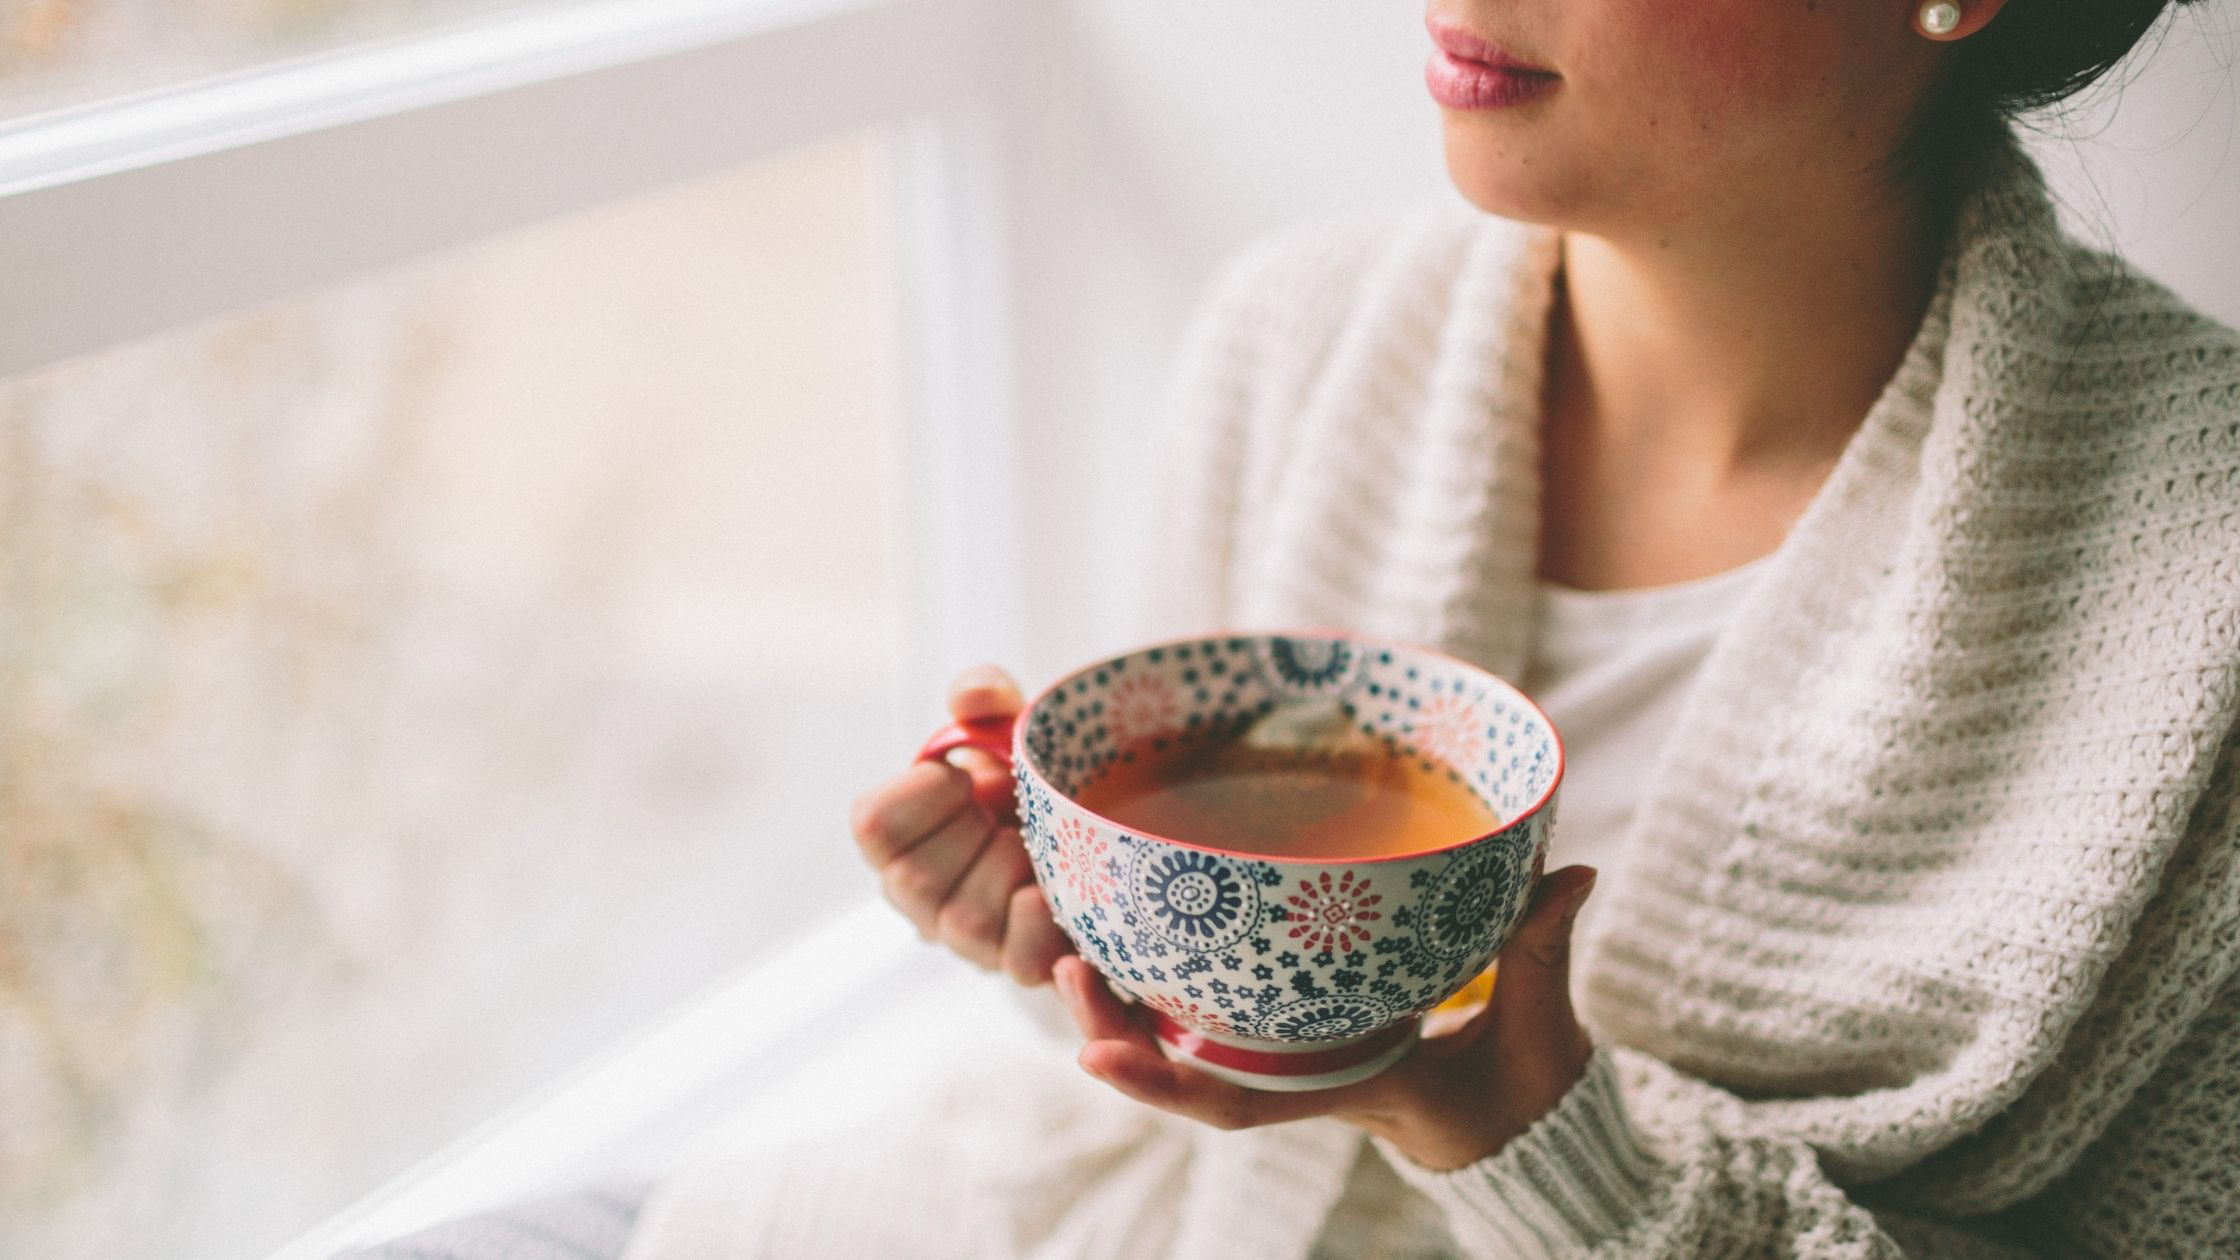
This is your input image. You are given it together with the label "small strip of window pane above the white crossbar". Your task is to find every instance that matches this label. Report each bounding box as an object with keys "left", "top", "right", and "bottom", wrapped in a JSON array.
[{"left": 0, "top": 0, "right": 548, "bottom": 119}]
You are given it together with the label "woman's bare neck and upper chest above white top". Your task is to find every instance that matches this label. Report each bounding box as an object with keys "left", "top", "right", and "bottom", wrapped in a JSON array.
[{"left": 1539, "top": 177, "right": 1935, "bottom": 590}]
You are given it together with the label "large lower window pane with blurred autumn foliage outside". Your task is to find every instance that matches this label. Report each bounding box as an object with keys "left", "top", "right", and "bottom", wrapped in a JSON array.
[{"left": 0, "top": 132, "right": 912, "bottom": 1260}]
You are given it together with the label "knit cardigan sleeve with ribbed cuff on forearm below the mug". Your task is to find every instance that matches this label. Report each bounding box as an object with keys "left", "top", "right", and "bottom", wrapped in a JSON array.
[{"left": 1378, "top": 964, "right": 2240, "bottom": 1260}]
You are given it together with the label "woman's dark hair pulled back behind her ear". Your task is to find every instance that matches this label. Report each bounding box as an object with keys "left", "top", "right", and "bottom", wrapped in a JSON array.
[{"left": 1895, "top": 0, "right": 2200, "bottom": 204}]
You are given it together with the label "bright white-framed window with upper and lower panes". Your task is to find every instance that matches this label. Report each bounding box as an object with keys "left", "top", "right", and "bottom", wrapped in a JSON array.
[{"left": 0, "top": 0, "right": 1015, "bottom": 1260}]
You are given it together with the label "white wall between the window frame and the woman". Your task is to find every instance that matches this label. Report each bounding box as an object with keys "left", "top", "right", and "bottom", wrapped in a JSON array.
[{"left": 1015, "top": 0, "right": 1452, "bottom": 679}]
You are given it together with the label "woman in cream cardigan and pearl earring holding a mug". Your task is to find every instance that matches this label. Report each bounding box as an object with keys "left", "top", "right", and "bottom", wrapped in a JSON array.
[{"left": 358, "top": 0, "right": 2240, "bottom": 1260}]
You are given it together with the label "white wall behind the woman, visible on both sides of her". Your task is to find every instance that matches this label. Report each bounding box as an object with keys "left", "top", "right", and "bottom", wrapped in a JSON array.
[{"left": 1015, "top": 0, "right": 2240, "bottom": 679}]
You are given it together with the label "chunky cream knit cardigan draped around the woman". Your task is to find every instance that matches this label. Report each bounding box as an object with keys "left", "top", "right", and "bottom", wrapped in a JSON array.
[{"left": 636, "top": 137, "right": 2240, "bottom": 1260}]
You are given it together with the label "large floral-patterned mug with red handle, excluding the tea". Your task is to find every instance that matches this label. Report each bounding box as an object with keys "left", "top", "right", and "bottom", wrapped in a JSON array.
[{"left": 921, "top": 634, "right": 1564, "bottom": 1090}]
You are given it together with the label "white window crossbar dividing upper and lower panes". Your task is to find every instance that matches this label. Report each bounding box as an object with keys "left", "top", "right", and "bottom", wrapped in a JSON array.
[{"left": 0, "top": 0, "right": 1008, "bottom": 377}]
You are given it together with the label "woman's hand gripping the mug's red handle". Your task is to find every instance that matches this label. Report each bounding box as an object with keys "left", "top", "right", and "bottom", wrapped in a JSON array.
[{"left": 849, "top": 666, "right": 1073, "bottom": 984}]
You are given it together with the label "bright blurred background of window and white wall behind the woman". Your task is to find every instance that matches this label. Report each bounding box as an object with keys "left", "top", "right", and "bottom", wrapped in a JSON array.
[{"left": 0, "top": 0, "right": 2240, "bottom": 1260}]
